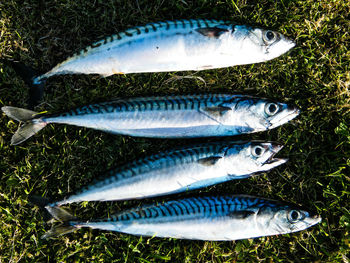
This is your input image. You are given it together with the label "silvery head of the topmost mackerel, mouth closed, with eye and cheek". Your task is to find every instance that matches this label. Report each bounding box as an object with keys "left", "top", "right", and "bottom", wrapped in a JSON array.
[{"left": 249, "top": 28, "right": 295, "bottom": 62}]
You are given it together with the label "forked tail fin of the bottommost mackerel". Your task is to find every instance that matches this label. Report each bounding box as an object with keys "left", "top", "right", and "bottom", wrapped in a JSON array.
[{"left": 41, "top": 205, "right": 79, "bottom": 239}]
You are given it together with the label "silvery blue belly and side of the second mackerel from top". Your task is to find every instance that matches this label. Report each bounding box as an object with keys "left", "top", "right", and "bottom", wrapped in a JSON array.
[{"left": 45, "top": 110, "right": 238, "bottom": 138}]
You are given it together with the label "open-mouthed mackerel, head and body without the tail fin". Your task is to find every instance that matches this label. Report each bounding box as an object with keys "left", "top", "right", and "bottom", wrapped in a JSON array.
[{"left": 47, "top": 141, "right": 287, "bottom": 207}]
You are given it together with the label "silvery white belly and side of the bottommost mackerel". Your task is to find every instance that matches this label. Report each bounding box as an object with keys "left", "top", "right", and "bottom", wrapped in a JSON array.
[{"left": 84, "top": 216, "right": 262, "bottom": 241}]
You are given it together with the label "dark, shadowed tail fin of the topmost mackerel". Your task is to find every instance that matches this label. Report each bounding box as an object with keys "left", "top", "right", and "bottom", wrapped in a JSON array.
[{"left": 1, "top": 59, "right": 46, "bottom": 109}]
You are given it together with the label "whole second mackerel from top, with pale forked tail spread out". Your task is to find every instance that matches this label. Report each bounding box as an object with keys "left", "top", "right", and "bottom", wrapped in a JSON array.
[{"left": 2, "top": 94, "right": 299, "bottom": 145}]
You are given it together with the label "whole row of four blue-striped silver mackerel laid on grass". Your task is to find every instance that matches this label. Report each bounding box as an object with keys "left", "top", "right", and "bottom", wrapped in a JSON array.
[{"left": 2, "top": 19, "right": 321, "bottom": 240}]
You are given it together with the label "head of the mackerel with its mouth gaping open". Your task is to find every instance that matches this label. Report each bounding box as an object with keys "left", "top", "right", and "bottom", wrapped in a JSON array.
[{"left": 224, "top": 141, "right": 287, "bottom": 177}]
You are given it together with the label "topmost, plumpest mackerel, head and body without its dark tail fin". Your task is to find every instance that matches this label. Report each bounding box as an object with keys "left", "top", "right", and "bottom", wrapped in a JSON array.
[{"left": 33, "top": 19, "right": 295, "bottom": 84}]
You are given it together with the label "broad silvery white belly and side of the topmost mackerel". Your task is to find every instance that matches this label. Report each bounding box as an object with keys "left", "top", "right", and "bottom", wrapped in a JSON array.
[{"left": 47, "top": 29, "right": 233, "bottom": 77}]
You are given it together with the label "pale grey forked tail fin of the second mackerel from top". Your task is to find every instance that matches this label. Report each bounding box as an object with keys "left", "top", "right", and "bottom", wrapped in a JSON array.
[{"left": 1, "top": 106, "right": 47, "bottom": 145}]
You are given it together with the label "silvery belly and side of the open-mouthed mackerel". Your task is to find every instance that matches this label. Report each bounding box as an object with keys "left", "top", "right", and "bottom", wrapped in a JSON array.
[{"left": 73, "top": 162, "right": 228, "bottom": 202}]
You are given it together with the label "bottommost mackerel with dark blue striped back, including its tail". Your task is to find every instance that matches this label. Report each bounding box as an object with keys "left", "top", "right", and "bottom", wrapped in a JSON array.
[{"left": 44, "top": 195, "right": 321, "bottom": 241}]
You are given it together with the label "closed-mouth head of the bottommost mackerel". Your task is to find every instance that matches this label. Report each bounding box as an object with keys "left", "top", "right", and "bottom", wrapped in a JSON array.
[{"left": 257, "top": 205, "right": 322, "bottom": 235}]
